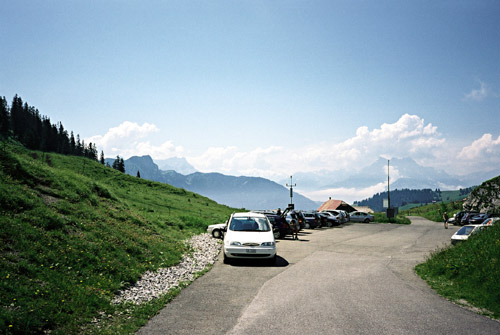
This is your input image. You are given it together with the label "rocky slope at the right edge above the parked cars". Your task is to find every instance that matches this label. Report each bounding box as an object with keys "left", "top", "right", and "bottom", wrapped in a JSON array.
[{"left": 463, "top": 176, "right": 500, "bottom": 214}]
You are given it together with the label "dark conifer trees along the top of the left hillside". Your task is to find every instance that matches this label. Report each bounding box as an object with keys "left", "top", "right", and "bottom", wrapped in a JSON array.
[{"left": 0, "top": 94, "right": 125, "bottom": 172}]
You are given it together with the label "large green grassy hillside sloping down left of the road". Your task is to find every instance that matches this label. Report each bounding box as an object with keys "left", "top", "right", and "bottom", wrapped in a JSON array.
[{"left": 0, "top": 142, "right": 233, "bottom": 334}]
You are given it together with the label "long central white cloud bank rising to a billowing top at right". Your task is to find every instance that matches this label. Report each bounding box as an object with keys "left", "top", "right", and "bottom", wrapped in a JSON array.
[{"left": 189, "top": 114, "right": 445, "bottom": 180}]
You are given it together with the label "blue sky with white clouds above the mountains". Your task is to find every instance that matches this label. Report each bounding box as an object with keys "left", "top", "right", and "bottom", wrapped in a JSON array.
[{"left": 0, "top": 0, "right": 500, "bottom": 200}]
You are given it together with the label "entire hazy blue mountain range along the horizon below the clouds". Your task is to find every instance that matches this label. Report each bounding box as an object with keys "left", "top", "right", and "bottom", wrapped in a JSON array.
[{"left": 106, "top": 155, "right": 498, "bottom": 210}]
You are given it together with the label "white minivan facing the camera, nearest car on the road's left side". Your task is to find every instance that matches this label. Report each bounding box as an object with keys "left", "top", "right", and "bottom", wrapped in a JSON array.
[{"left": 224, "top": 212, "right": 276, "bottom": 264}]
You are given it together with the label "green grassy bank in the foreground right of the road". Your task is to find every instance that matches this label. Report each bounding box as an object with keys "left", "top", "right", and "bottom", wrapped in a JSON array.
[{"left": 415, "top": 225, "right": 500, "bottom": 319}]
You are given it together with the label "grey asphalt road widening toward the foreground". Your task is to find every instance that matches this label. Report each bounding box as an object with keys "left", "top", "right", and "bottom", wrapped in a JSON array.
[{"left": 138, "top": 217, "right": 500, "bottom": 335}]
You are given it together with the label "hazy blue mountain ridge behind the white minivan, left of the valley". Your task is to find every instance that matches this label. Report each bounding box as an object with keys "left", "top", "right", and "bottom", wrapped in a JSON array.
[{"left": 106, "top": 155, "right": 319, "bottom": 210}]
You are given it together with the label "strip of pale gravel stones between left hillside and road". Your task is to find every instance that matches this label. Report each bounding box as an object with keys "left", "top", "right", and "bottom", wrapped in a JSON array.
[{"left": 112, "top": 233, "right": 222, "bottom": 305}]
